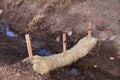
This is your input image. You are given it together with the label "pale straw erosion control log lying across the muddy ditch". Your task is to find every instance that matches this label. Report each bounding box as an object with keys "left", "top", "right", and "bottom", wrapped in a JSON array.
[{"left": 31, "top": 37, "right": 97, "bottom": 74}]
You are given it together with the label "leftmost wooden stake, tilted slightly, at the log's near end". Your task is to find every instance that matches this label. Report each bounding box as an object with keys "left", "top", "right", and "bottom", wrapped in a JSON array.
[{"left": 25, "top": 34, "right": 33, "bottom": 60}]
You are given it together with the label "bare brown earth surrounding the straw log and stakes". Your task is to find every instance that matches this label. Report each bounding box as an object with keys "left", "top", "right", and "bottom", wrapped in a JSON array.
[{"left": 0, "top": 0, "right": 120, "bottom": 80}]
